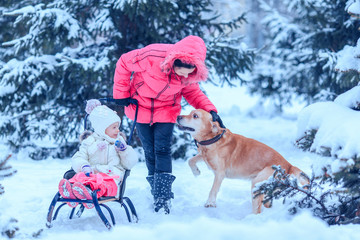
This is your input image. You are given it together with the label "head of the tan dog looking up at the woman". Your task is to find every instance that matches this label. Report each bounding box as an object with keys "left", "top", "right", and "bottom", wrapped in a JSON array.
[{"left": 177, "top": 109, "right": 220, "bottom": 140}]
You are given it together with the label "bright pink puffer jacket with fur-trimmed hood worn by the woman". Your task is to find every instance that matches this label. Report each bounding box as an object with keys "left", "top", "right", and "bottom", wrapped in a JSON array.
[{"left": 113, "top": 36, "right": 217, "bottom": 124}]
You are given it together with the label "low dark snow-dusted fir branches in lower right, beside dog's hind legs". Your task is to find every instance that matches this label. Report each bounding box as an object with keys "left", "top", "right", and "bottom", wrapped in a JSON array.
[{"left": 254, "top": 164, "right": 360, "bottom": 225}]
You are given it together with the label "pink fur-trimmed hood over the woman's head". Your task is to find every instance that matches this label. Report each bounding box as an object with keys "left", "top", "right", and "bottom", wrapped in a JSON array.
[{"left": 161, "top": 36, "right": 208, "bottom": 83}]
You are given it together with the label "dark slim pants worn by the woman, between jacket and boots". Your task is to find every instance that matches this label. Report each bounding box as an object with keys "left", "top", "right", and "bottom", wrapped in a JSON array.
[{"left": 136, "top": 123, "right": 175, "bottom": 175}]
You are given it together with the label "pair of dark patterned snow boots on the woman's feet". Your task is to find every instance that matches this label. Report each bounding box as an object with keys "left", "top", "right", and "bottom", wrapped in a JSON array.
[{"left": 154, "top": 173, "right": 175, "bottom": 214}]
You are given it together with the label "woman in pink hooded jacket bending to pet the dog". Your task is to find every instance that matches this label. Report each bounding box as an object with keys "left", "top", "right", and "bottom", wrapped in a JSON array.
[{"left": 113, "top": 36, "right": 221, "bottom": 213}]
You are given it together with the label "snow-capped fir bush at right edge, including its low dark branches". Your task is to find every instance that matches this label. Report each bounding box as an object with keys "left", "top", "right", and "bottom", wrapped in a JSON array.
[{"left": 278, "top": 87, "right": 360, "bottom": 224}]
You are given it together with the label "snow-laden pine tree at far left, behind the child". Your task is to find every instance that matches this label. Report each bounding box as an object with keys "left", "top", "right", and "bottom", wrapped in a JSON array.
[{"left": 0, "top": 1, "right": 111, "bottom": 158}]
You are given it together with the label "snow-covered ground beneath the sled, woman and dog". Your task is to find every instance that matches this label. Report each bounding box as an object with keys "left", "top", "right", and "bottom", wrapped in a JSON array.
[{"left": 0, "top": 85, "right": 360, "bottom": 240}]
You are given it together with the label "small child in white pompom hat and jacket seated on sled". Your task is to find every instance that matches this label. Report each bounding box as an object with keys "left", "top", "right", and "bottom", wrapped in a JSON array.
[{"left": 59, "top": 99, "right": 138, "bottom": 208}]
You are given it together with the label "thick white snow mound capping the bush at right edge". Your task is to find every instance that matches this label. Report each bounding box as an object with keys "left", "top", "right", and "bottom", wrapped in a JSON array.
[{"left": 296, "top": 87, "right": 360, "bottom": 163}]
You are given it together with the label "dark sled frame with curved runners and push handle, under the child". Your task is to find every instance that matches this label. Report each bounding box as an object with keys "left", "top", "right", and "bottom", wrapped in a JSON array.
[{"left": 46, "top": 98, "right": 139, "bottom": 230}]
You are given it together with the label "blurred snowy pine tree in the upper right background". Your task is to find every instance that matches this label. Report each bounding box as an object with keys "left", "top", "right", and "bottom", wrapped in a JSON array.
[{"left": 250, "top": 0, "right": 360, "bottom": 106}]
